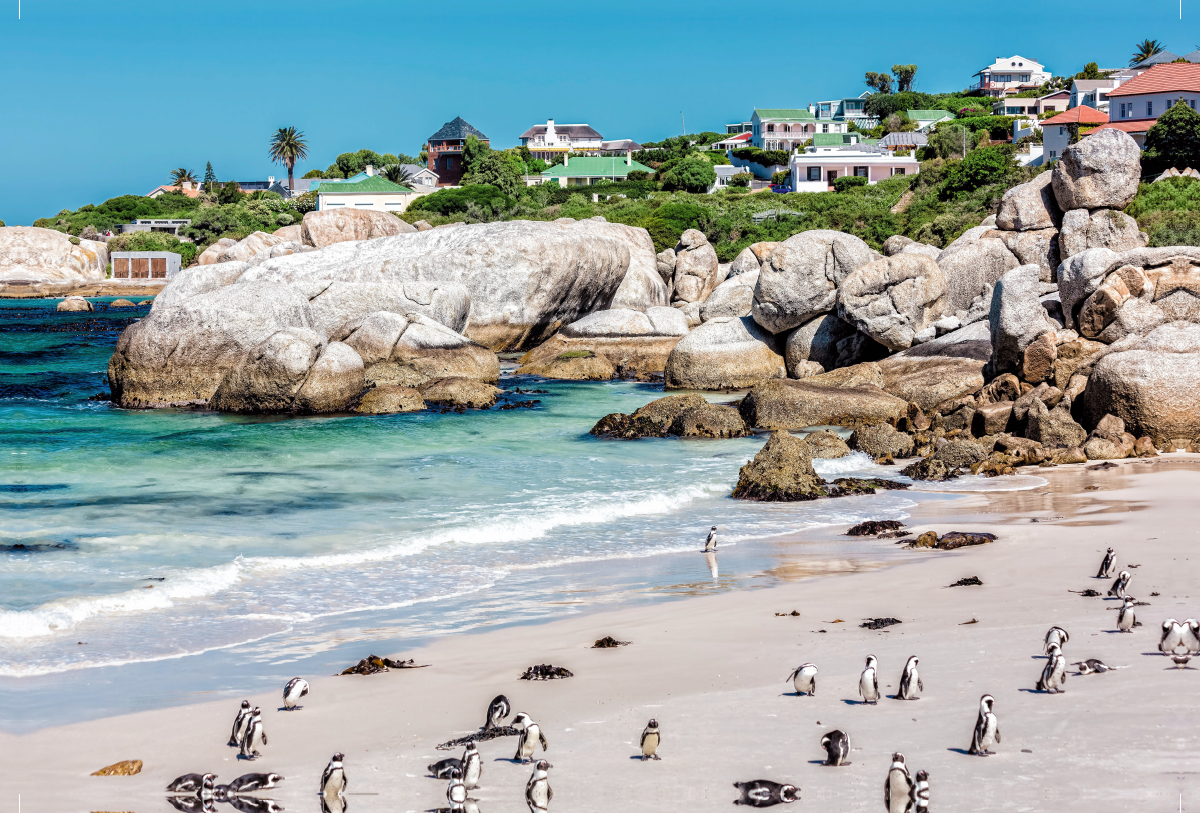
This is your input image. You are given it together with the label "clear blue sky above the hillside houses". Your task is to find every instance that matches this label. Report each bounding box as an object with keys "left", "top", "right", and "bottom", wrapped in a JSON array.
[{"left": 0, "top": 0, "right": 1200, "bottom": 225}]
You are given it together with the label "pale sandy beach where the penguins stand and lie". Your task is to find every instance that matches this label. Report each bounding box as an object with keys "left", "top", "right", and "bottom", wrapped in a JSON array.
[{"left": 0, "top": 453, "right": 1200, "bottom": 813}]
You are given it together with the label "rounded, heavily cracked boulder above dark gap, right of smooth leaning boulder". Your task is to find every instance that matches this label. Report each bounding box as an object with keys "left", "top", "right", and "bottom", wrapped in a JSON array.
[{"left": 838, "top": 253, "right": 947, "bottom": 350}]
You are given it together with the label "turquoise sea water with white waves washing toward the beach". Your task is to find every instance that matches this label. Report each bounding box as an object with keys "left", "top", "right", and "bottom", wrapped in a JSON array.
[{"left": 0, "top": 301, "right": 1044, "bottom": 730}]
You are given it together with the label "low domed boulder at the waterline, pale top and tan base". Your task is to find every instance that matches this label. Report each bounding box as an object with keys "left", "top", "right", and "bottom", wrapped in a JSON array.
[{"left": 665, "top": 317, "right": 787, "bottom": 390}]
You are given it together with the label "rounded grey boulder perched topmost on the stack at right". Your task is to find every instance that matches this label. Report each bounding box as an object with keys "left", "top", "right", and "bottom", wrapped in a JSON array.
[{"left": 1052, "top": 130, "right": 1141, "bottom": 211}]
